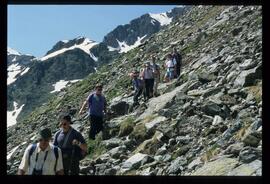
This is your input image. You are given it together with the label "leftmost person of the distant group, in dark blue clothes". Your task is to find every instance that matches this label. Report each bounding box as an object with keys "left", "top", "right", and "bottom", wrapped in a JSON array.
[{"left": 129, "top": 70, "right": 143, "bottom": 107}]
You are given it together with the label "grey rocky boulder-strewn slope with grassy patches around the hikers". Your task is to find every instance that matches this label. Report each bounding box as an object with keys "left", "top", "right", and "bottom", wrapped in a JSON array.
[{"left": 7, "top": 6, "right": 262, "bottom": 176}]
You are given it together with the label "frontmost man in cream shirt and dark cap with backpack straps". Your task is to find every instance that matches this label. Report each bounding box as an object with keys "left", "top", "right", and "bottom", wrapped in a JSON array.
[{"left": 18, "top": 128, "right": 64, "bottom": 175}]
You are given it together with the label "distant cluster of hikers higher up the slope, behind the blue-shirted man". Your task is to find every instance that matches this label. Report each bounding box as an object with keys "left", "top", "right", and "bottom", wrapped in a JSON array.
[{"left": 129, "top": 48, "right": 182, "bottom": 107}]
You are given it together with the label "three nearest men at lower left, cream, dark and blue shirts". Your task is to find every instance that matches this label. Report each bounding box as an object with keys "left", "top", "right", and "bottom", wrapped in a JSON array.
[{"left": 18, "top": 84, "right": 107, "bottom": 175}]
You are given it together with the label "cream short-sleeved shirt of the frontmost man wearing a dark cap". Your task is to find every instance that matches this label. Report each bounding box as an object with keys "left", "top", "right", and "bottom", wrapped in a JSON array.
[{"left": 19, "top": 143, "right": 63, "bottom": 175}]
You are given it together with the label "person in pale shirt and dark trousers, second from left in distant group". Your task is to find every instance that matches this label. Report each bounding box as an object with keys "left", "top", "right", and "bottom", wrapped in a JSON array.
[{"left": 140, "top": 62, "right": 154, "bottom": 101}]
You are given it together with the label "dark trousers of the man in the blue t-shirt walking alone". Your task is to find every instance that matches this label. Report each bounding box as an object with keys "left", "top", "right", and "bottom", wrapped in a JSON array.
[{"left": 89, "top": 115, "right": 103, "bottom": 140}]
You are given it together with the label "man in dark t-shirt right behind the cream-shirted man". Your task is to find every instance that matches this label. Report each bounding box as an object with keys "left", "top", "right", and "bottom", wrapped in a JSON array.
[{"left": 53, "top": 114, "right": 87, "bottom": 175}]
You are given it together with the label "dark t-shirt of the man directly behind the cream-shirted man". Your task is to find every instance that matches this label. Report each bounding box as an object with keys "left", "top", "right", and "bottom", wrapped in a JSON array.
[{"left": 53, "top": 127, "right": 86, "bottom": 156}]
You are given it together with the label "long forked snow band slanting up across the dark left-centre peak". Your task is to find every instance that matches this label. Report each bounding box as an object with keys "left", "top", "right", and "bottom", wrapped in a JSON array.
[{"left": 40, "top": 37, "right": 98, "bottom": 61}]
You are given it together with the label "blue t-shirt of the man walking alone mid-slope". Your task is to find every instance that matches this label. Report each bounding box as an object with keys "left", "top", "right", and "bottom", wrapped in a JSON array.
[{"left": 87, "top": 92, "right": 107, "bottom": 117}]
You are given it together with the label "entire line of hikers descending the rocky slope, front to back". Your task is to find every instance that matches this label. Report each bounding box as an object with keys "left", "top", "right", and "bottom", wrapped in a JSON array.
[{"left": 18, "top": 49, "right": 181, "bottom": 175}]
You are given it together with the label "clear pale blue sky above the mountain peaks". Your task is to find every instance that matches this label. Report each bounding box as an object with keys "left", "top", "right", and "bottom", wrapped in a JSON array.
[{"left": 7, "top": 5, "right": 175, "bottom": 57}]
